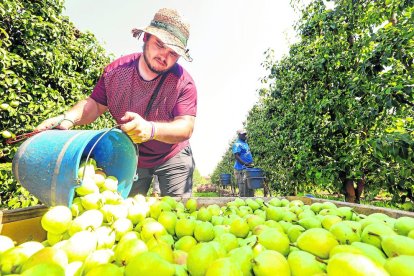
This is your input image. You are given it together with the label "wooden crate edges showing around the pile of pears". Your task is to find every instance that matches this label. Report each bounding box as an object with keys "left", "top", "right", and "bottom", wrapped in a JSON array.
[{"left": 0, "top": 196, "right": 414, "bottom": 243}]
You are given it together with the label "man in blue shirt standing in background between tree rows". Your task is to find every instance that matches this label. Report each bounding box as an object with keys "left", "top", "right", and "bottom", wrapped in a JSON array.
[{"left": 232, "top": 129, "right": 254, "bottom": 197}]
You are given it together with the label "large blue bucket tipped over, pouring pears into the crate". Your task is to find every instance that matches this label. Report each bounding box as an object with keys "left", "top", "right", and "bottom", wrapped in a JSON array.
[{"left": 13, "top": 129, "right": 138, "bottom": 206}]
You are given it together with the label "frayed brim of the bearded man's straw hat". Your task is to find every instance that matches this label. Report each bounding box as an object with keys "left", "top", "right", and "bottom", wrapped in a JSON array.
[{"left": 134, "top": 26, "right": 193, "bottom": 62}]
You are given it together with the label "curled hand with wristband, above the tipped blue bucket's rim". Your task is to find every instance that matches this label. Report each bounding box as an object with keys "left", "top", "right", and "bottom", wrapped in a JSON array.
[{"left": 121, "top": 112, "right": 152, "bottom": 144}]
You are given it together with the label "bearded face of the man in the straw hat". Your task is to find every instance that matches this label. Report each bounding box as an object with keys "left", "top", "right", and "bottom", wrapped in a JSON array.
[{"left": 144, "top": 35, "right": 180, "bottom": 74}]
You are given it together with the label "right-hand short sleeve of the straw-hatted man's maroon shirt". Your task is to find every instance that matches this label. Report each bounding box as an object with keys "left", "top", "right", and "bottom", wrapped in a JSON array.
[{"left": 173, "top": 82, "right": 197, "bottom": 117}]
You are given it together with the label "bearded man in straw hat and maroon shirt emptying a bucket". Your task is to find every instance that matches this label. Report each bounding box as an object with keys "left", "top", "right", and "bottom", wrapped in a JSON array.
[{"left": 37, "top": 9, "right": 197, "bottom": 196}]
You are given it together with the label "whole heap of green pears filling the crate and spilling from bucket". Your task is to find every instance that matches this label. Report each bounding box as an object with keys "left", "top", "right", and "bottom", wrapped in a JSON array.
[{"left": 0, "top": 159, "right": 414, "bottom": 276}]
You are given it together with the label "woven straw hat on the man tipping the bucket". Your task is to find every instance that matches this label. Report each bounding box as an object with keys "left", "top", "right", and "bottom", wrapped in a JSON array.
[{"left": 132, "top": 8, "right": 193, "bottom": 61}]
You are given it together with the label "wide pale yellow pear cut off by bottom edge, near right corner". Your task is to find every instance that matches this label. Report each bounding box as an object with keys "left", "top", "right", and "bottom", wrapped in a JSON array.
[{"left": 326, "top": 253, "right": 389, "bottom": 276}]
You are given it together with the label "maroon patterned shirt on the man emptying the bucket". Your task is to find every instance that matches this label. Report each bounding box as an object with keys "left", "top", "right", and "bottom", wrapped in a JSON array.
[{"left": 91, "top": 53, "right": 197, "bottom": 168}]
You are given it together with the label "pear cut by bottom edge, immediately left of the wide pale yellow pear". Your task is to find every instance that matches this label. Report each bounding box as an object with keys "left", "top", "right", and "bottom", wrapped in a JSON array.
[{"left": 287, "top": 250, "right": 326, "bottom": 276}]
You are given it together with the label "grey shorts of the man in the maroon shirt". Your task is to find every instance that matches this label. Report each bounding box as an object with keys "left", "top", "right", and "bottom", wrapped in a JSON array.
[{"left": 129, "top": 146, "right": 195, "bottom": 197}]
